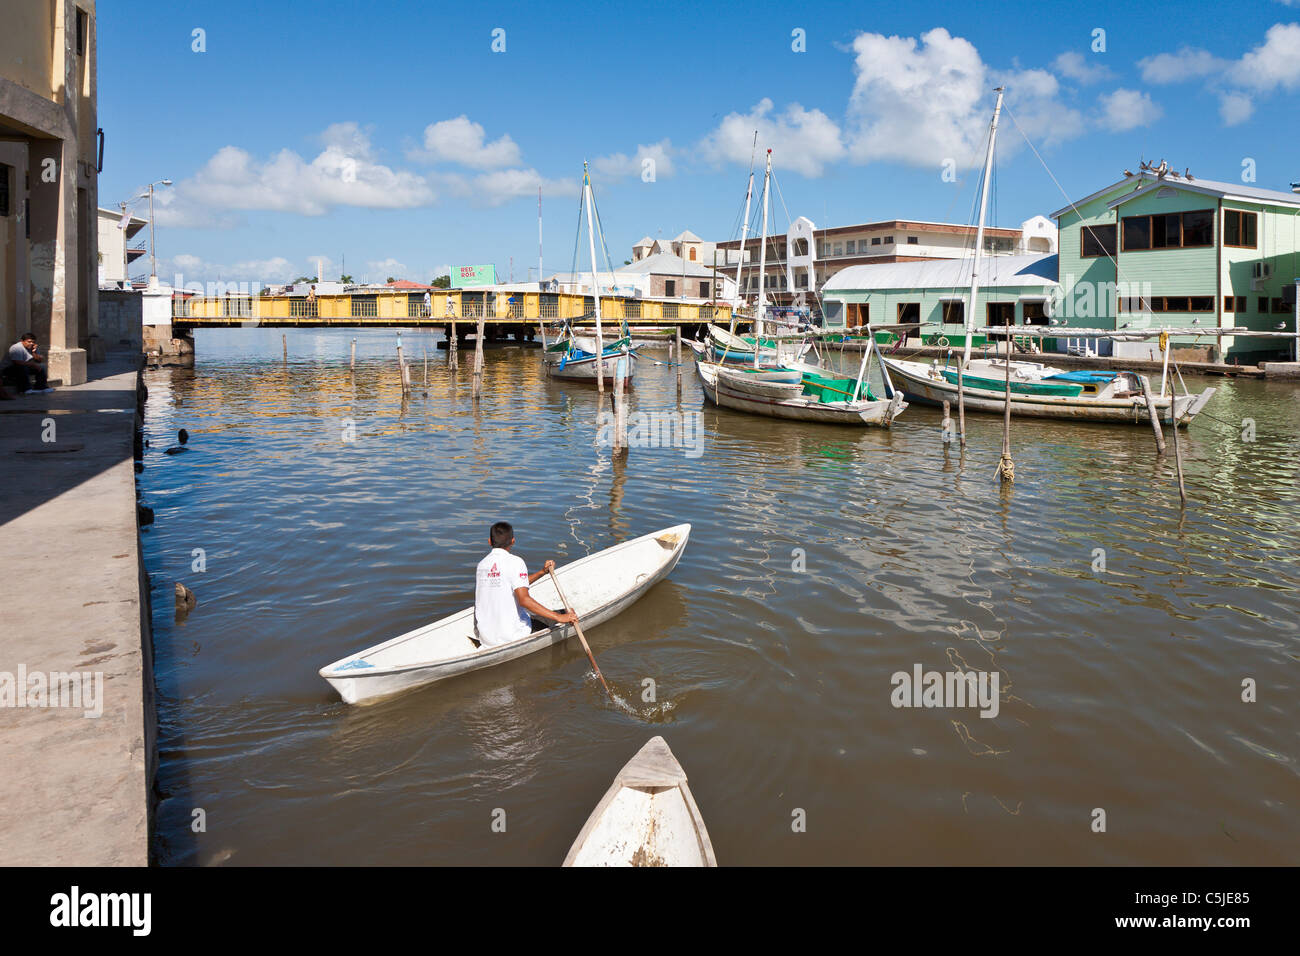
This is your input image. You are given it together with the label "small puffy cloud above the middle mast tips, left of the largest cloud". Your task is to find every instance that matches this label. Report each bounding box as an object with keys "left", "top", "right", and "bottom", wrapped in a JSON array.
[{"left": 699, "top": 96, "right": 845, "bottom": 178}]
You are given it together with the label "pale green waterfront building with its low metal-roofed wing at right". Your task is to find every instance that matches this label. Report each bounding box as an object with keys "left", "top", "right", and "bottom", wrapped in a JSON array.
[{"left": 822, "top": 170, "right": 1300, "bottom": 363}]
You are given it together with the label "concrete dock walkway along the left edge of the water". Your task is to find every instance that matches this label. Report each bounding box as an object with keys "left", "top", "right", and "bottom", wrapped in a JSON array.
[{"left": 0, "top": 354, "right": 156, "bottom": 866}]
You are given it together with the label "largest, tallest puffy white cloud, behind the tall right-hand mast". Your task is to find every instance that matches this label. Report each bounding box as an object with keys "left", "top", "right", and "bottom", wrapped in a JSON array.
[{"left": 849, "top": 27, "right": 1086, "bottom": 166}]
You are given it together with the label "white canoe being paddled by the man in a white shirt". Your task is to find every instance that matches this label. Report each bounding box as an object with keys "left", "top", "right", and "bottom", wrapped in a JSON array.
[{"left": 320, "top": 524, "right": 690, "bottom": 704}]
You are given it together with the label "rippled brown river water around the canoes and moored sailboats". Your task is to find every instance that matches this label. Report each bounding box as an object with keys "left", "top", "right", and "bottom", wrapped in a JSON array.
[{"left": 140, "top": 329, "right": 1300, "bottom": 866}]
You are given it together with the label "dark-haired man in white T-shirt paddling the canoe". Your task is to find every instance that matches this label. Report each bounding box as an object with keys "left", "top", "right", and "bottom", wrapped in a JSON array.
[{"left": 475, "top": 522, "right": 577, "bottom": 646}]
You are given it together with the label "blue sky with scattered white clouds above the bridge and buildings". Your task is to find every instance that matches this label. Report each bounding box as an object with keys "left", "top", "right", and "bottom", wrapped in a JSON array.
[{"left": 99, "top": 0, "right": 1300, "bottom": 284}]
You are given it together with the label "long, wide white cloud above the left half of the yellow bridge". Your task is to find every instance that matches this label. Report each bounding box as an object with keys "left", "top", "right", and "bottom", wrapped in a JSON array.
[{"left": 156, "top": 124, "right": 434, "bottom": 226}]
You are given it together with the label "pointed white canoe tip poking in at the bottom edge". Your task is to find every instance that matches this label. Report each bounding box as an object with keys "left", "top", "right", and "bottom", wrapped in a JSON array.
[{"left": 564, "top": 737, "right": 718, "bottom": 866}]
